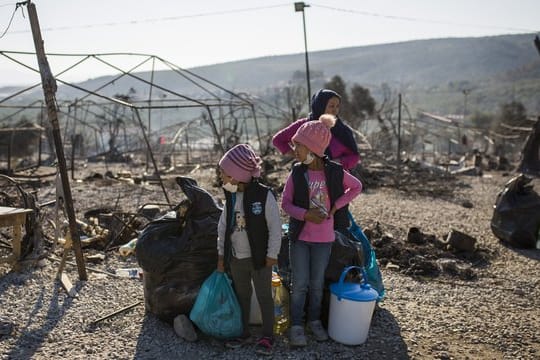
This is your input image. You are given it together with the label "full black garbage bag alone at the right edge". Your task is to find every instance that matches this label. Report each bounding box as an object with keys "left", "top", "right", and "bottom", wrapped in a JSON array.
[{"left": 491, "top": 174, "right": 540, "bottom": 248}]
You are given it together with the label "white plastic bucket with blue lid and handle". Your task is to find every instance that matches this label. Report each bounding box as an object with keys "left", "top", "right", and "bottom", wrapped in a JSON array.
[{"left": 328, "top": 266, "right": 379, "bottom": 345}]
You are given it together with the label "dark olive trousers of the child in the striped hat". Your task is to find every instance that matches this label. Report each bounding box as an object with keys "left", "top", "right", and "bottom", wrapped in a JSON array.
[{"left": 231, "top": 257, "right": 274, "bottom": 337}]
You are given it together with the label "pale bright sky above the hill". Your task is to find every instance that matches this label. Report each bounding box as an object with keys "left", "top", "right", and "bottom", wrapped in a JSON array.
[{"left": 0, "top": 0, "right": 540, "bottom": 87}]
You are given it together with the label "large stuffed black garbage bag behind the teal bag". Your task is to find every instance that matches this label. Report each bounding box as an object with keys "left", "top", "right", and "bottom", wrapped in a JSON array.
[{"left": 136, "top": 177, "right": 222, "bottom": 322}]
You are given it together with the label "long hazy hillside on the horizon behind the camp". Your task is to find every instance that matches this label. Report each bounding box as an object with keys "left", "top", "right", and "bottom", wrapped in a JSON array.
[{"left": 0, "top": 34, "right": 540, "bottom": 114}]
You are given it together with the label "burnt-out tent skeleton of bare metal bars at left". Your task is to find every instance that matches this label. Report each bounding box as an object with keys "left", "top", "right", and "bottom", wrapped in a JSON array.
[{"left": 0, "top": 51, "right": 287, "bottom": 177}]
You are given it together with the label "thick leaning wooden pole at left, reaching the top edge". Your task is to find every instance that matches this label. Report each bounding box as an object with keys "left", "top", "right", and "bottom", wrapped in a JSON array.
[{"left": 27, "top": 1, "right": 87, "bottom": 280}]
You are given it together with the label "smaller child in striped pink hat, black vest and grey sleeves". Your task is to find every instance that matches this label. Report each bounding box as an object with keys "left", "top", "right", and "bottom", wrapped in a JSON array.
[{"left": 218, "top": 144, "right": 281, "bottom": 355}]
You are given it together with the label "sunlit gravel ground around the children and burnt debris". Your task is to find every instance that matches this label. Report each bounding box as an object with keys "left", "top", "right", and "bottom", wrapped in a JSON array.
[{"left": 0, "top": 164, "right": 540, "bottom": 359}]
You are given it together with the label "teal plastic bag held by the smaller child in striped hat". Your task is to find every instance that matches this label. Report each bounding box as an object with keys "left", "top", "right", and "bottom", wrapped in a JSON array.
[{"left": 189, "top": 270, "right": 243, "bottom": 339}]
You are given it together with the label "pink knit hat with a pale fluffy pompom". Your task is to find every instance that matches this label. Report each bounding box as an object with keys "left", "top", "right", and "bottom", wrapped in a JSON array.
[{"left": 292, "top": 114, "right": 336, "bottom": 157}]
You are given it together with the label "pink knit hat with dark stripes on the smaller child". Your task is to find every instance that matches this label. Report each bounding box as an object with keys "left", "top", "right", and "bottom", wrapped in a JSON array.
[{"left": 219, "top": 144, "right": 261, "bottom": 183}]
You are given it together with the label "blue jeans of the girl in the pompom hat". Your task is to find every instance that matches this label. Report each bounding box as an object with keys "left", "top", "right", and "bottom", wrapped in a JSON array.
[{"left": 290, "top": 240, "right": 332, "bottom": 326}]
